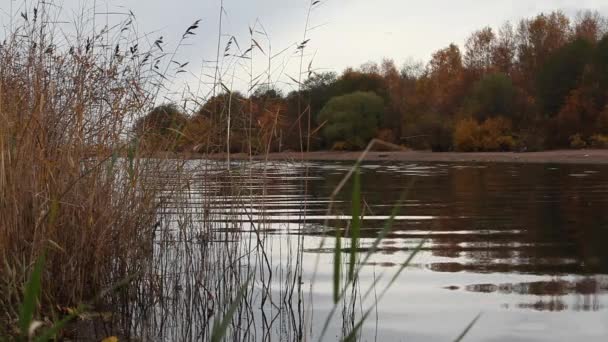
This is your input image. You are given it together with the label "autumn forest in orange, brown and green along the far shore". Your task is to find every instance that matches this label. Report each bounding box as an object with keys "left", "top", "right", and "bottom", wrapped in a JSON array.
[{"left": 134, "top": 11, "right": 608, "bottom": 154}]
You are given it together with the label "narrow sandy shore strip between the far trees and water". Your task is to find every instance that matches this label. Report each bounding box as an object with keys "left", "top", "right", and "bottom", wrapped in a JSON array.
[{"left": 191, "top": 150, "right": 608, "bottom": 164}]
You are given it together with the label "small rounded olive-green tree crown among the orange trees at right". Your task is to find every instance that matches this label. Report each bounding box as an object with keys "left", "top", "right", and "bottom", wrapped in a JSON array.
[{"left": 467, "top": 73, "right": 516, "bottom": 121}]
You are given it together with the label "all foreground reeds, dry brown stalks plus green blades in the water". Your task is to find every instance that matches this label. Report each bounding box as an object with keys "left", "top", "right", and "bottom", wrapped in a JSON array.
[{"left": 0, "top": 1, "right": 464, "bottom": 341}]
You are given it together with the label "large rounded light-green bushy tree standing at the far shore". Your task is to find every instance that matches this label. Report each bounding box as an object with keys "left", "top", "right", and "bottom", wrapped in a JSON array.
[{"left": 319, "top": 91, "right": 384, "bottom": 149}]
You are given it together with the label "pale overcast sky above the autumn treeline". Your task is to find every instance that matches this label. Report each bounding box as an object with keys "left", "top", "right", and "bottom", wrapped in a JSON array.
[{"left": 0, "top": 0, "right": 608, "bottom": 97}]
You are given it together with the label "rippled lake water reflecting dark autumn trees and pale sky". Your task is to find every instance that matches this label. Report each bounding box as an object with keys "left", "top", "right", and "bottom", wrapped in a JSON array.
[{"left": 141, "top": 162, "right": 608, "bottom": 341}]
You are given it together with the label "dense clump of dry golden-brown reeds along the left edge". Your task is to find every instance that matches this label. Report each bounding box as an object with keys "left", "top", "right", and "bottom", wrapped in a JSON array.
[{"left": 0, "top": 1, "right": 186, "bottom": 331}]
